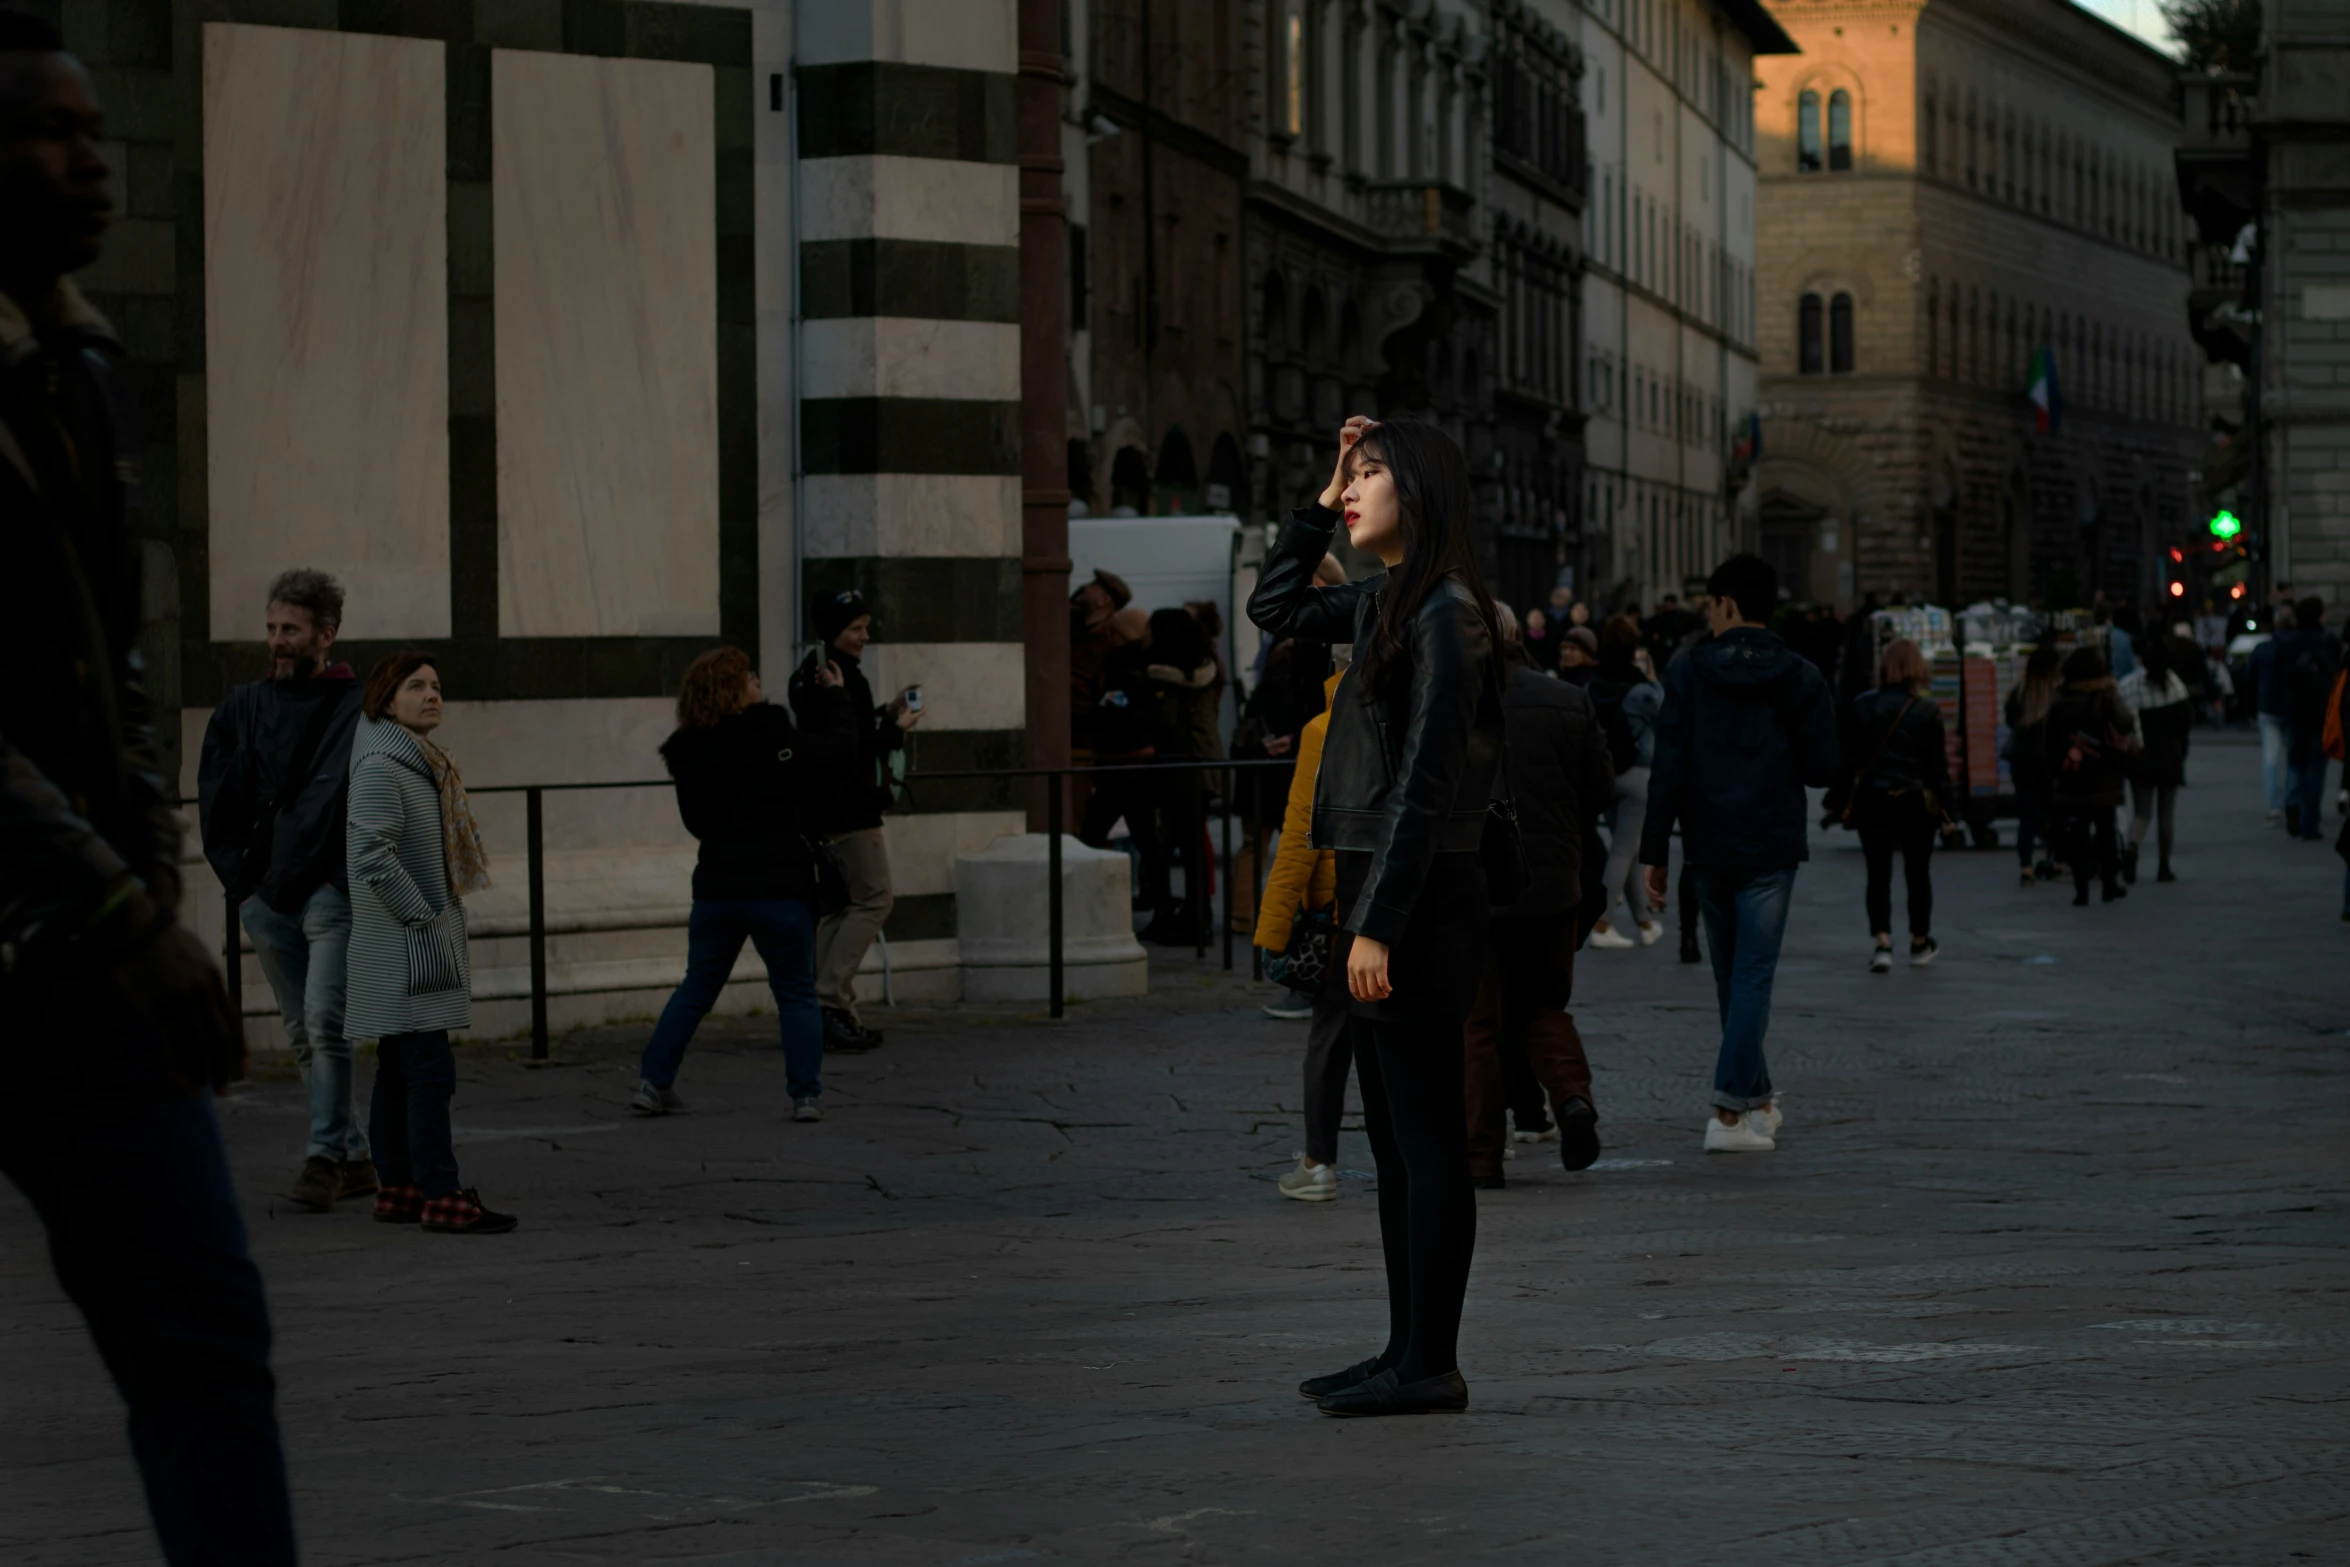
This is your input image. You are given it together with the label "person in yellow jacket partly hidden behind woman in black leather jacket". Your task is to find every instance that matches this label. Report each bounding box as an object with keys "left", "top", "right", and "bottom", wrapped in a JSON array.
[{"left": 1253, "top": 672, "right": 1354, "bottom": 1203}]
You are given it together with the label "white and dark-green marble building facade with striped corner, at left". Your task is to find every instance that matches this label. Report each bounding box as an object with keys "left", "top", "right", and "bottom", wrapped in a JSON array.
[{"left": 56, "top": 0, "right": 1025, "bottom": 1031}]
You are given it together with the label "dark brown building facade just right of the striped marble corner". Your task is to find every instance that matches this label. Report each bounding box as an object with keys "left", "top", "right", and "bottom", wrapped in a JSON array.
[{"left": 1069, "top": 0, "right": 1248, "bottom": 515}]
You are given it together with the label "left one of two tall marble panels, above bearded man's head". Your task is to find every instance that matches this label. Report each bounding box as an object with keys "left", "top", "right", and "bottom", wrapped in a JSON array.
[{"left": 202, "top": 21, "right": 449, "bottom": 639}]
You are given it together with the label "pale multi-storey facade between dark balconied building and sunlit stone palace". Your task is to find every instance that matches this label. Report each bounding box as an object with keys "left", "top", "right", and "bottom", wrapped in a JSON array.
[{"left": 1577, "top": 0, "right": 1793, "bottom": 606}]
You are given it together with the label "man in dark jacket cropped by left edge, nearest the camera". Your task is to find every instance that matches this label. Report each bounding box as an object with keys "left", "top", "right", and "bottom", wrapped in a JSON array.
[{"left": 0, "top": 9, "right": 294, "bottom": 1567}]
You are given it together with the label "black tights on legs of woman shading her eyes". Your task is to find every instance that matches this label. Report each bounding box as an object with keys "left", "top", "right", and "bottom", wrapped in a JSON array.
[{"left": 1347, "top": 1017, "right": 1476, "bottom": 1381}]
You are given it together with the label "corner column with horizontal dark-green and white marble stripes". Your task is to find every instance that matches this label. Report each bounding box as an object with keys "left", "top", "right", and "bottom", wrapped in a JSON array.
[{"left": 797, "top": 0, "right": 1025, "bottom": 967}]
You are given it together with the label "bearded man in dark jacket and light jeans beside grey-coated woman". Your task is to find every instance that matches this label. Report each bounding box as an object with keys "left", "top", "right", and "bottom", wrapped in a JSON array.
[{"left": 197, "top": 569, "right": 376, "bottom": 1212}]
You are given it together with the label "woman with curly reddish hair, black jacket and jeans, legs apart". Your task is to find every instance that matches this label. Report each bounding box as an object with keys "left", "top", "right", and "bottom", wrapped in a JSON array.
[{"left": 627, "top": 648, "right": 855, "bottom": 1121}]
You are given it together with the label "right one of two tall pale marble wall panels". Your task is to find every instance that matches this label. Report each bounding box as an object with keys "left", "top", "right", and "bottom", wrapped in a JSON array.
[{"left": 491, "top": 49, "right": 719, "bottom": 637}]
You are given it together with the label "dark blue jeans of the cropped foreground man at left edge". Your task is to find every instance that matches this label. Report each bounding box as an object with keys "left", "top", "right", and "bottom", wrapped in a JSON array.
[{"left": 0, "top": 1090, "right": 294, "bottom": 1567}]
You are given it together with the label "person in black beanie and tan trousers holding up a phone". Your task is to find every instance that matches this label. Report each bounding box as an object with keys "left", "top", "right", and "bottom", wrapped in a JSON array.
[{"left": 792, "top": 587, "right": 921, "bottom": 1055}]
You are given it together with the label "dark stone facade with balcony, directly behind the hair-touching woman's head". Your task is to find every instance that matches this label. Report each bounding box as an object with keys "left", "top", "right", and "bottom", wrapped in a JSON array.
[{"left": 1240, "top": 0, "right": 1502, "bottom": 556}]
